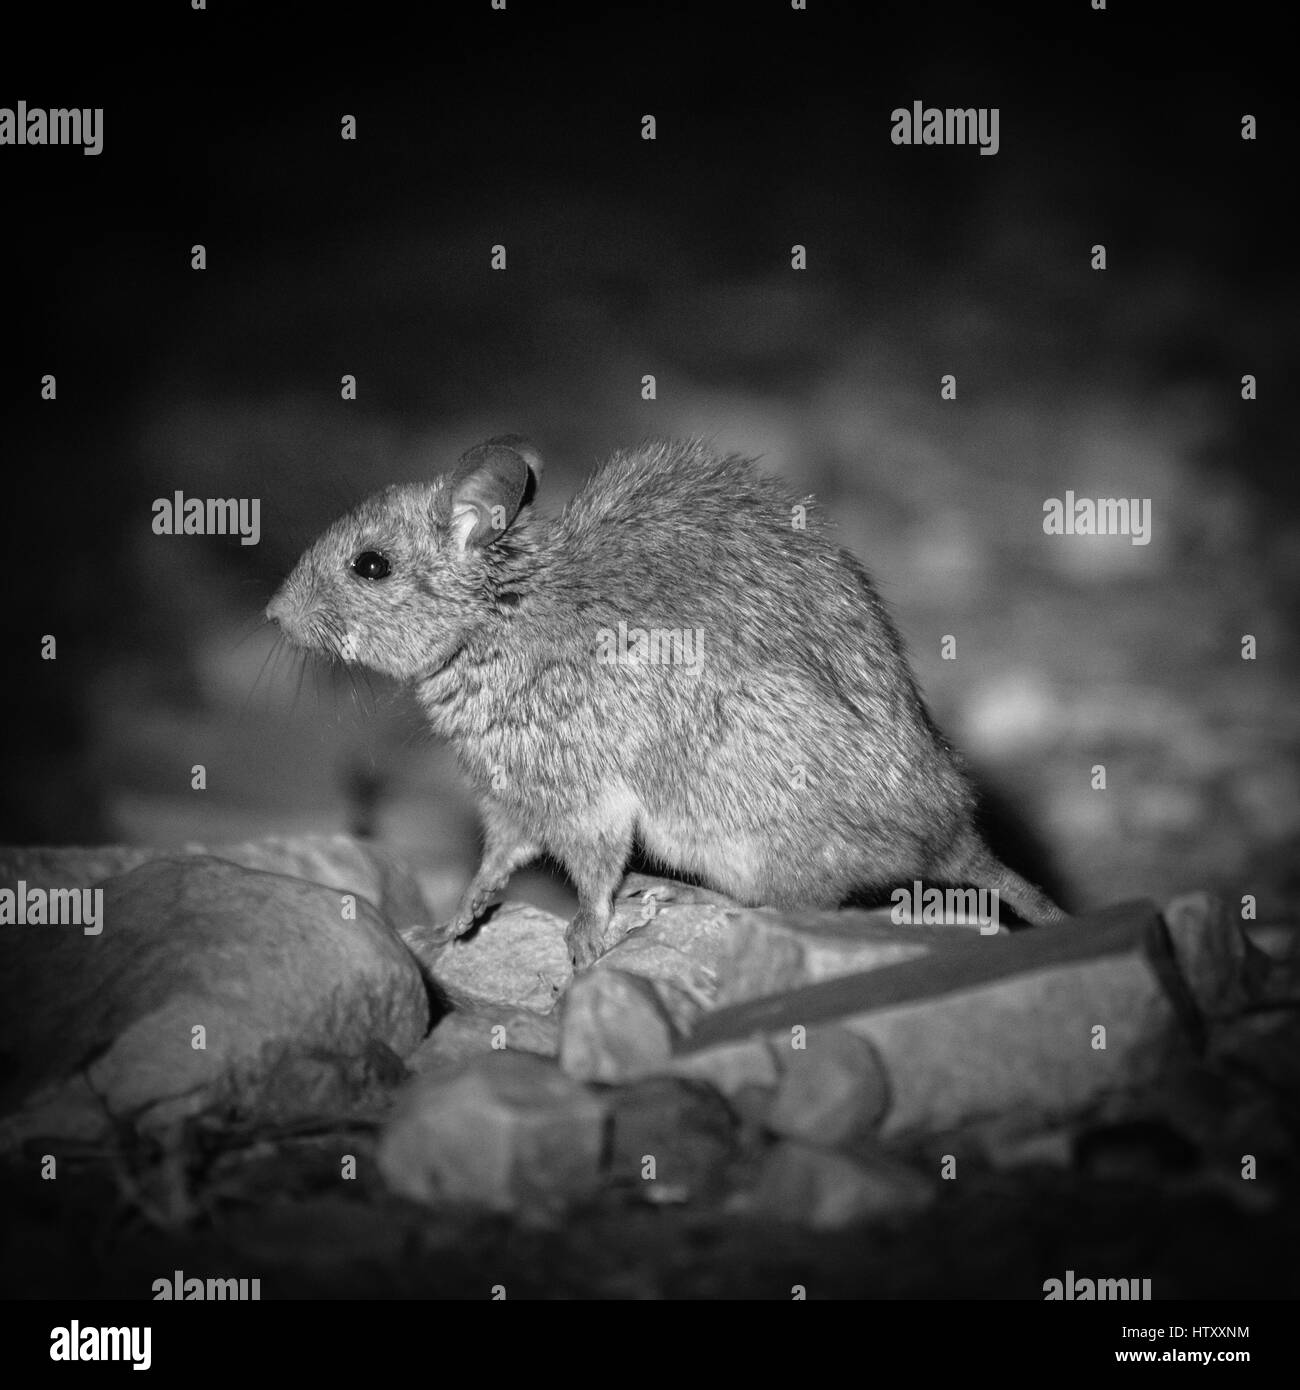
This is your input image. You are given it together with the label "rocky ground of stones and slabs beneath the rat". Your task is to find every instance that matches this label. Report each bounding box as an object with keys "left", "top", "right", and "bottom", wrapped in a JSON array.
[{"left": 0, "top": 837, "right": 1300, "bottom": 1298}]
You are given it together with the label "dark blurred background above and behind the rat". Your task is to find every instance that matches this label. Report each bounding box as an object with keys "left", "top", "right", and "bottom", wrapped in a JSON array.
[{"left": 0, "top": 0, "right": 1300, "bottom": 919}]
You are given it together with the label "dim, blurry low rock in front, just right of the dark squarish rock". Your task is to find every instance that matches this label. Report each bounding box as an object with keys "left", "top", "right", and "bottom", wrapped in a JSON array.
[{"left": 734, "top": 1140, "right": 936, "bottom": 1230}]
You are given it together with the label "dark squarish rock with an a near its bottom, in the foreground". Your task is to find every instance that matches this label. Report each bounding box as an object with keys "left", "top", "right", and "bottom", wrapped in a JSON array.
[{"left": 608, "top": 1076, "right": 736, "bottom": 1202}]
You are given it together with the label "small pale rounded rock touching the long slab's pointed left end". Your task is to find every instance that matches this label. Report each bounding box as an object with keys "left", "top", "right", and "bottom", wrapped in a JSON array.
[{"left": 560, "top": 969, "right": 674, "bottom": 1083}]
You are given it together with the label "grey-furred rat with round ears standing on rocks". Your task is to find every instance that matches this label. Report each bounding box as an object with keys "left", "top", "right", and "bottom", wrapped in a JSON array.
[{"left": 267, "top": 435, "right": 1065, "bottom": 969}]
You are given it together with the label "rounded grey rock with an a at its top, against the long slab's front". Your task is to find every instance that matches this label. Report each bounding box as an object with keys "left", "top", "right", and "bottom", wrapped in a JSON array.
[{"left": 766, "top": 1027, "right": 888, "bottom": 1148}]
